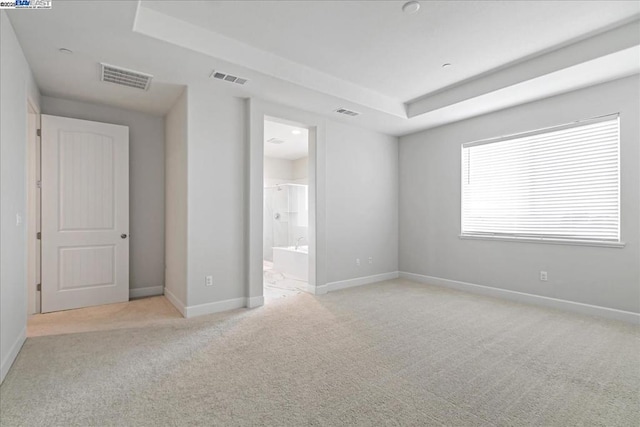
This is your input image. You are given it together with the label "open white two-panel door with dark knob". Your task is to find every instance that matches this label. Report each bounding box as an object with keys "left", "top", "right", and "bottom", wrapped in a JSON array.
[{"left": 41, "top": 115, "right": 129, "bottom": 313}]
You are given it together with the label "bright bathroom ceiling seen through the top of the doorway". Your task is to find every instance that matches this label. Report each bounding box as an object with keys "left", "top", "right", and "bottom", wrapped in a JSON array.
[{"left": 264, "top": 120, "right": 309, "bottom": 160}]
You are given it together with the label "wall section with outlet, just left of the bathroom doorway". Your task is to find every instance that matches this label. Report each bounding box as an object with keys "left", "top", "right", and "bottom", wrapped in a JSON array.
[{"left": 187, "top": 82, "right": 248, "bottom": 306}]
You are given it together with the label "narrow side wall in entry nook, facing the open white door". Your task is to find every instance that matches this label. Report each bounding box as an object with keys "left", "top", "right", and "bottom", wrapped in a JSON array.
[{"left": 164, "top": 89, "right": 188, "bottom": 308}]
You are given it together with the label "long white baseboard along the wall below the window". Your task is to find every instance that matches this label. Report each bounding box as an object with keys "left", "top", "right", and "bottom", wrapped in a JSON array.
[{"left": 400, "top": 271, "right": 640, "bottom": 324}]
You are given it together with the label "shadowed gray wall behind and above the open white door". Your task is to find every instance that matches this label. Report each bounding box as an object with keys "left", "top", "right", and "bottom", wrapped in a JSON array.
[{"left": 42, "top": 96, "right": 165, "bottom": 289}]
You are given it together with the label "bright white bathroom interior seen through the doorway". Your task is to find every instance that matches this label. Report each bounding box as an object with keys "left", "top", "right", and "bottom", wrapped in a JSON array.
[{"left": 263, "top": 118, "right": 309, "bottom": 302}]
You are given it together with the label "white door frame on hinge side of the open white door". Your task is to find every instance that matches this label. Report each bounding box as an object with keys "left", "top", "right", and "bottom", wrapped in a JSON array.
[{"left": 25, "top": 97, "right": 42, "bottom": 315}]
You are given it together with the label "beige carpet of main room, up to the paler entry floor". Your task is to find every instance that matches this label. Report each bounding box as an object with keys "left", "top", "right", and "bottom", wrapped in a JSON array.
[{"left": 0, "top": 280, "right": 640, "bottom": 427}]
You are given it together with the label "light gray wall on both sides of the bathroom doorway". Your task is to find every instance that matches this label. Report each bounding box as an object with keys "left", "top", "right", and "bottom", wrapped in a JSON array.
[{"left": 180, "top": 84, "right": 398, "bottom": 306}]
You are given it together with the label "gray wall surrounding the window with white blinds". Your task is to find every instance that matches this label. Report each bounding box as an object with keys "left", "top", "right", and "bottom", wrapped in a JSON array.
[{"left": 399, "top": 75, "right": 640, "bottom": 312}]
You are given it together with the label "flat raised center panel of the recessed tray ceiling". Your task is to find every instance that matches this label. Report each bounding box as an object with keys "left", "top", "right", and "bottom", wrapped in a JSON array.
[{"left": 142, "top": 1, "right": 640, "bottom": 102}]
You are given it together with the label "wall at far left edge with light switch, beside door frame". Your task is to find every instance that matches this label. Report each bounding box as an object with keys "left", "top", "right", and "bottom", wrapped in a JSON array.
[{"left": 0, "top": 11, "right": 40, "bottom": 381}]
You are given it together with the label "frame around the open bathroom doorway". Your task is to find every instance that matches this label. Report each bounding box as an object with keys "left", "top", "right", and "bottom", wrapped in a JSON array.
[{"left": 245, "top": 99, "right": 327, "bottom": 308}]
